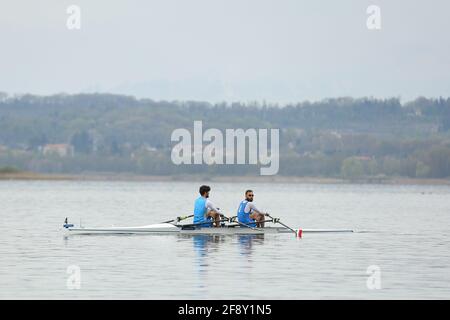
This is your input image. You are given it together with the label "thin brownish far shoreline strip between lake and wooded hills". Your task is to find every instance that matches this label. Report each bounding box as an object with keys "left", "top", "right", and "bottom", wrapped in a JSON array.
[{"left": 0, "top": 172, "right": 450, "bottom": 185}]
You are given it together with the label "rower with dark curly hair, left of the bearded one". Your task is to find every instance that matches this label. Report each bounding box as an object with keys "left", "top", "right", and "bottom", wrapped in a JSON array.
[{"left": 194, "top": 185, "right": 220, "bottom": 228}]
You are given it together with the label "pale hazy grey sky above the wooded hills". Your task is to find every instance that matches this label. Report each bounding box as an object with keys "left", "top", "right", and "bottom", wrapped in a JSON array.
[{"left": 0, "top": 0, "right": 450, "bottom": 103}]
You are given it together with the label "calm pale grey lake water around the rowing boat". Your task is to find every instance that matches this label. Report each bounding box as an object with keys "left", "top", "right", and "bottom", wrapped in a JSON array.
[{"left": 0, "top": 181, "right": 450, "bottom": 299}]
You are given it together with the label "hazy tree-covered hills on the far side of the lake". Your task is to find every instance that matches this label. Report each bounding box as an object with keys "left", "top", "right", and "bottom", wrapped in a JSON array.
[{"left": 0, "top": 94, "right": 450, "bottom": 179}]
